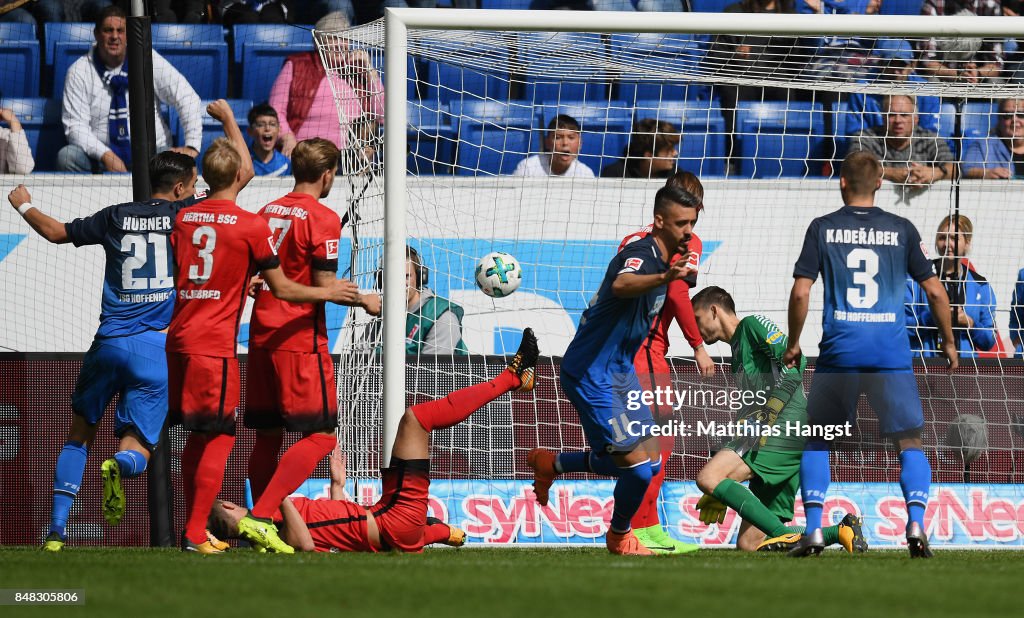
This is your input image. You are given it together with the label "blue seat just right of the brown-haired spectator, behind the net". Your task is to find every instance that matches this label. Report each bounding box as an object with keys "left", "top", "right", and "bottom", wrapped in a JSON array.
[{"left": 635, "top": 99, "right": 726, "bottom": 178}]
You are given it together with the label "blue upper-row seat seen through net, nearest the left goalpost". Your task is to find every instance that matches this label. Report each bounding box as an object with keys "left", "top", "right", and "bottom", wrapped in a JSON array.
[{"left": 424, "top": 45, "right": 509, "bottom": 104}]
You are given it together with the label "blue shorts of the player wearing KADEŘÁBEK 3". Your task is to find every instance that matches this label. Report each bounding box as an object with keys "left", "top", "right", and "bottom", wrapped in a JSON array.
[{"left": 807, "top": 366, "right": 925, "bottom": 436}]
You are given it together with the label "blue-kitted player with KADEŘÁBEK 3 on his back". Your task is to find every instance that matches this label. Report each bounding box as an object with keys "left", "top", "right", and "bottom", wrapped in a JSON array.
[{"left": 783, "top": 151, "right": 957, "bottom": 558}]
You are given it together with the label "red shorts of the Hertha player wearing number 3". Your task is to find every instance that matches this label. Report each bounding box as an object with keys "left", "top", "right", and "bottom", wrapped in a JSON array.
[{"left": 167, "top": 351, "right": 241, "bottom": 436}]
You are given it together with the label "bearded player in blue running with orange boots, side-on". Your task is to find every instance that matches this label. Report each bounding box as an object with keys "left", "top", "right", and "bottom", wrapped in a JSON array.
[{"left": 527, "top": 186, "right": 700, "bottom": 556}]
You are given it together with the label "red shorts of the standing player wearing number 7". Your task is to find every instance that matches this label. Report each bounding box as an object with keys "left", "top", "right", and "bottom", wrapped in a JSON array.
[{"left": 244, "top": 349, "right": 338, "bottom": 433}]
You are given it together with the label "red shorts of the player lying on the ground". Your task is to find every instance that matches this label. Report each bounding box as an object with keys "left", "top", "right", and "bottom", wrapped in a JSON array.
[{"left": 370, "top": 457, "right": 430, "bottom": 553}]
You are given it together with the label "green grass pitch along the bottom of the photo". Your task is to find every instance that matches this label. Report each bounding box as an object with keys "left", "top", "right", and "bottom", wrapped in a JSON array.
[{"left": 0, "top": 547, "right": 1024, "bottom": 618}]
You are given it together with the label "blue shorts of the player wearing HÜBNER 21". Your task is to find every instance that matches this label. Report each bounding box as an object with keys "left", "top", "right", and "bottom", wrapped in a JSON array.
[{"left": 71, "top": 330, "right": 167, "bottom": 450}]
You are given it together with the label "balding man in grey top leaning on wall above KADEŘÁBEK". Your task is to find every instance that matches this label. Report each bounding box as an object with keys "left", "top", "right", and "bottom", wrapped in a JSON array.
[{"left": 849, "top": 94, "right": 953, "bottom": 190}]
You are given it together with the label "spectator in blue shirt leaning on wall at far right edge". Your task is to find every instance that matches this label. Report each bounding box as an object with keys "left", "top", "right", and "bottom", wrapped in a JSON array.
[{"left": 963, "top": 98, "right": 1024, "bottom": 179}]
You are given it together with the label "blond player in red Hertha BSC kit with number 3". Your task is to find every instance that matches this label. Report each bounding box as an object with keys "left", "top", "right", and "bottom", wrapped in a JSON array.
[{"left": 167, "top": 100, "right": 358, "bottom": 554}]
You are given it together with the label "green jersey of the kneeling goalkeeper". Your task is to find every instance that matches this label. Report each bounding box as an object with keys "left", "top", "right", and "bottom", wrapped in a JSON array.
[{"left": 729, "top": 315, "right": 807, "bottom": 456}]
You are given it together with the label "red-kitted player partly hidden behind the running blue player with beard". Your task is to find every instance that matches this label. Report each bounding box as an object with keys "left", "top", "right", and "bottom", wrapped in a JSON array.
[{"left": 618, "top": 172, "right": 715, "bottom": 554}]
